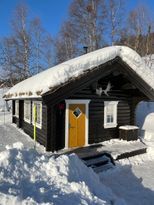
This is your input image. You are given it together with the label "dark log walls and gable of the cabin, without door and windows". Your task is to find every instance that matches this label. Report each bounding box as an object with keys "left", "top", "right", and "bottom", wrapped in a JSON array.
[{"left": 13, "top": 58, "right": 154, "bottom": 151}]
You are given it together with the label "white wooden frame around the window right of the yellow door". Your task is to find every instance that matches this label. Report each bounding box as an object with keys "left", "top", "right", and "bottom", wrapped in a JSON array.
[{"left": 104, "top": 101, "right": 118, "bottom": 128}]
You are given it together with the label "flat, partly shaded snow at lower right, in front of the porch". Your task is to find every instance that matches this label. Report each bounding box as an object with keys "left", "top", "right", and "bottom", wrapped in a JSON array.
[{"left": 100, "top": 147, "right": 154, "bottom": 205}]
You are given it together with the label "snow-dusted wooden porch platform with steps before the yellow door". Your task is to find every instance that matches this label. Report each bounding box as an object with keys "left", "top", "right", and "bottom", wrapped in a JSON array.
[{"left": 59, "top": 140, "right": 147, "bottom": 173}]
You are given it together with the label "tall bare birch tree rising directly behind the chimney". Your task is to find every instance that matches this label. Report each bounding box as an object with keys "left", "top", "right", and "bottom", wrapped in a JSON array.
[{"left": 70, "top": 0, "right": 106, "bottom": 51}]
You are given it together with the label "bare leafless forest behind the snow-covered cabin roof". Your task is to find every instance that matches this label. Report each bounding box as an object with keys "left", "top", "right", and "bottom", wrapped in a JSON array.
[{"left": 0, "top": 0, "right": 154, "bottom": 86}]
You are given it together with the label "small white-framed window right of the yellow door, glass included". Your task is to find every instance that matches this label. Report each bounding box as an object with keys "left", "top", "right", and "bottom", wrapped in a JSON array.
[{"left": 104, "top": 101, "right": 118, "bottom": 128}]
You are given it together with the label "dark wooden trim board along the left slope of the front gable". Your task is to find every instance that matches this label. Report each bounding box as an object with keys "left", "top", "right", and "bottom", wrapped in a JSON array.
[{"left": 42, "top": 58, "right": 117, "bottom": 104}]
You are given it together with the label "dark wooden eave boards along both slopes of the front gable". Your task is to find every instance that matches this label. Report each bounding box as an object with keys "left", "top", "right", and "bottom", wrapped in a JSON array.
[{"left": 42, "top": 57, "right": 154, "bottom": 104}]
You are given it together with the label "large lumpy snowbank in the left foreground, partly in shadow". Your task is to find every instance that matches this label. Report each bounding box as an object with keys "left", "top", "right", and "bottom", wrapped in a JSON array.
[{"left": 0, "top": 143, "right": 125, "bottom": 205}]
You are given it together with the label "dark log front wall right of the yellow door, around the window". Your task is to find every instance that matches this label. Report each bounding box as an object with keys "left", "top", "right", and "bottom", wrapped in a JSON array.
[{"left": 70, "top": 85, "right": 130, "bottom": 144}]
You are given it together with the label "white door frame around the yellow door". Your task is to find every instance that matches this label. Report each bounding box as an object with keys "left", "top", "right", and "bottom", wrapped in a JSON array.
[{"left": 65, "top": 99, "right": 90, "bottom": 149}]
